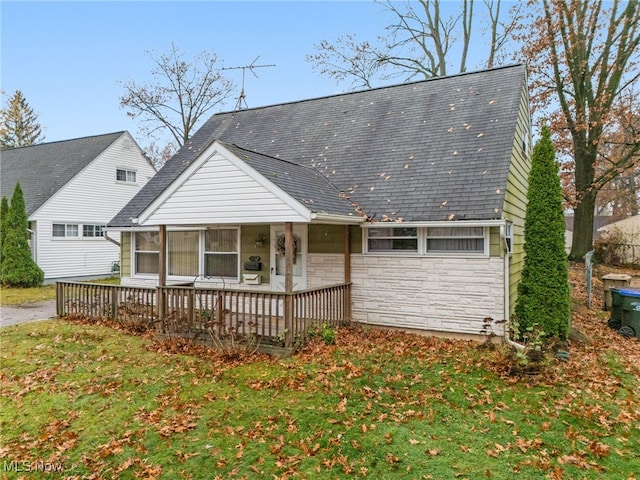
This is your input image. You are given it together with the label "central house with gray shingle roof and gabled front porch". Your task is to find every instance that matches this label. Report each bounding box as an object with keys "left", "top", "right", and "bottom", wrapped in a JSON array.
[{"left": 107, "top": 65, "right": 531, "bottom": 342}]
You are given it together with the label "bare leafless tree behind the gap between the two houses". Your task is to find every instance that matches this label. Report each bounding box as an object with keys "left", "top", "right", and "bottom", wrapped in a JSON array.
[{"left": 120, "top": 45, "right": 233, "bottom": 169}]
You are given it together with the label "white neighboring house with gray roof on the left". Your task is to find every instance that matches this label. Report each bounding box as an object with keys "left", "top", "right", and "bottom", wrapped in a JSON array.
[{"left": 0, "top": 132, "right": 155, "bottom": 281}]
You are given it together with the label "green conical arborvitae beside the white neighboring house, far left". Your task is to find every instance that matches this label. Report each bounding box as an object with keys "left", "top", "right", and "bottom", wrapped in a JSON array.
[{"left": 2, "top": 183, "right": 44, "bottom": 287}]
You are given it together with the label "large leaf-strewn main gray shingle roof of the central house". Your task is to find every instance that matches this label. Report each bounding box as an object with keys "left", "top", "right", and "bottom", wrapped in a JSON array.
[{"left": 110, "top": 65, "right": 526, "bottom": 226}]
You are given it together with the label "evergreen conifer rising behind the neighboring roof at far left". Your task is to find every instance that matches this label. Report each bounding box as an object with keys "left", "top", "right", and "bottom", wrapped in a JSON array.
[{"left": 0, "top": 90, "right": 44, "bottom": 148}]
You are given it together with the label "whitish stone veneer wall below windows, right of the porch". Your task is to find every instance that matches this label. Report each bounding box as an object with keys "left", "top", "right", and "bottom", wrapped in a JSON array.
[{"left": 351, "top": 255, "right": 504, "bottom": 335}]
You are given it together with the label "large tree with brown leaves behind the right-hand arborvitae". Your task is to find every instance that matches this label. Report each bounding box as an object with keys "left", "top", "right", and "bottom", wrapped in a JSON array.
[{"left": 516, "top": 0, "right": 640, "bottom": 261}]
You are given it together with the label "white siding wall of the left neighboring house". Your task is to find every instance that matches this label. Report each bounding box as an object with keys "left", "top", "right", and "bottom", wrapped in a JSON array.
[{"left": 29, "top": 133, "right": 155, "bottom": 279}]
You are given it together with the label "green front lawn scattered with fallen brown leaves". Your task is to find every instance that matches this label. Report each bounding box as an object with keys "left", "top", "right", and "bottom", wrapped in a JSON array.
[{"left": 0, "top": 266, "right": 640, "bottom": 480}]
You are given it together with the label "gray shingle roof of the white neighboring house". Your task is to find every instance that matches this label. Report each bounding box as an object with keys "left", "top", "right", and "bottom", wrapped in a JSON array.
[{"left": 0, "top": 132, "right": 125, "bottom": 216}]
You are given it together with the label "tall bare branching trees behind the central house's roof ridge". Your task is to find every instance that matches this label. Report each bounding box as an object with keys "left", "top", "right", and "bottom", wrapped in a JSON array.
[{"left": 306, "top": 0, "right": 519, "bottom": 88}]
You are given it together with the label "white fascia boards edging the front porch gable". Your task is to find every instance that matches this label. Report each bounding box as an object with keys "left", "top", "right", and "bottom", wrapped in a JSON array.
[{"left": 137, "top": 140, "right": 312, "bottom": 225}]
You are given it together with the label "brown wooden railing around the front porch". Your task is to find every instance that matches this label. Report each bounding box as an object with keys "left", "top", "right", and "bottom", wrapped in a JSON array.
[{"left": 56, "top": 282, "right": 351, "bottom": 347}]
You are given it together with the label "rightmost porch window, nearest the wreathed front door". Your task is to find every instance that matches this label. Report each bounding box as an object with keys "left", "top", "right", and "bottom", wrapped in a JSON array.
[{"left": 204, "top": 228, "right": 239, "bottom": 278}]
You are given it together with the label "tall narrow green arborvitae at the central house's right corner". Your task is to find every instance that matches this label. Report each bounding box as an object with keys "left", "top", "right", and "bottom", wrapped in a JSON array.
[{"left": 515, "top": 126, "right": 571, "bottom": 340}]
